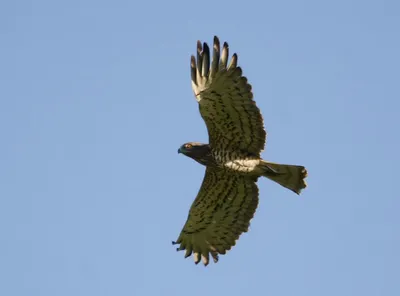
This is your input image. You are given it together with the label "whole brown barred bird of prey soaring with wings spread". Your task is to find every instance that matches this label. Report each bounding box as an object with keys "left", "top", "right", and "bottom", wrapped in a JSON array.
[{"left": 173, "top": 36, "right": 307, "bottom": 266}]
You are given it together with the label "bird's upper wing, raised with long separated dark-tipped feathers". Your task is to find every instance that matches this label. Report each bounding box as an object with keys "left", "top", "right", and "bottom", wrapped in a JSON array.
[{"left": 190, "top": 36, "right": 266, "bottom": 156}]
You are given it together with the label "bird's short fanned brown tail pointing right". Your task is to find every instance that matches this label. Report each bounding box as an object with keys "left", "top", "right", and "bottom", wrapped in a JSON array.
[{"left": 258, "top": 160, "right": 307, "bottom": 194}]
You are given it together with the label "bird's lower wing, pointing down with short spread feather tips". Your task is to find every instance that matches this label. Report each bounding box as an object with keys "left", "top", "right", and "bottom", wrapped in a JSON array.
[{"left": 173, "top": 167, "right": 258, "bottom": 265}]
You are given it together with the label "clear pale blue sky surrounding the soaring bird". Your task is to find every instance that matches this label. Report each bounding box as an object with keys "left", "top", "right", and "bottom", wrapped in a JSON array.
[{"left": 0, "top": 0, "right": 400, "bottom": 296}]
